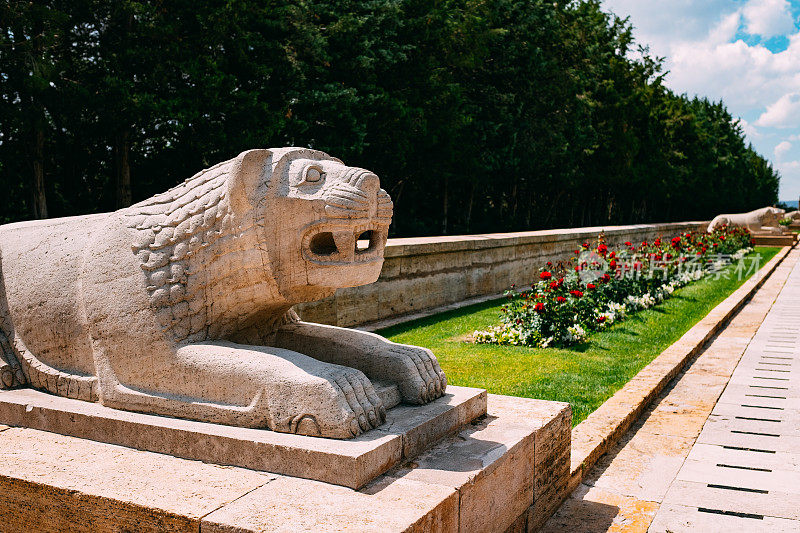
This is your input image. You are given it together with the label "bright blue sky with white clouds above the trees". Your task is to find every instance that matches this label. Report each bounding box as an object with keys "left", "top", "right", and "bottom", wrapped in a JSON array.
[{"left": 603, "top": 0, "right": 800, "bottom": 200}]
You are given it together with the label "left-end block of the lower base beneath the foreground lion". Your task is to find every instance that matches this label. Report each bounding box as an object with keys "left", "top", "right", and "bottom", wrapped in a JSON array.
[{"left": 0, "top": 428, "right": 275, "bottom": 533}]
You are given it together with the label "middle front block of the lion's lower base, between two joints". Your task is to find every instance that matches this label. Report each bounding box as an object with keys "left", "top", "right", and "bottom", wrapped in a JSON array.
[{"left": 201, "top": 477, "right": 459, "bottom": 533}]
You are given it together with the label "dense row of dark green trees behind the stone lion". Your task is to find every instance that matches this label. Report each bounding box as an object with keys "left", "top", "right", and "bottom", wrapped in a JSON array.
[{"left": 0, "top": 0, "right": 779, "bottom": 236}]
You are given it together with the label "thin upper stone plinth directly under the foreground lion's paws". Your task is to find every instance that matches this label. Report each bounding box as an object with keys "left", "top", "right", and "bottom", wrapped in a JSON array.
[{"left": 0, "top": 386, "right": 487, "bottom": 488}]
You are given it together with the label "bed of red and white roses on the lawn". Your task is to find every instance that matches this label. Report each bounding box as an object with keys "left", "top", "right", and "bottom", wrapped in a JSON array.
[{"left": 473, "top": 223, "right": 752, "bottom": 348}]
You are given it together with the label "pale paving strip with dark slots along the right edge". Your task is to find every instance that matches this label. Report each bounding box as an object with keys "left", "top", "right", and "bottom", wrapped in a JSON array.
[{"left": 650, "top": 246, "right": 800, "bottom": 531}]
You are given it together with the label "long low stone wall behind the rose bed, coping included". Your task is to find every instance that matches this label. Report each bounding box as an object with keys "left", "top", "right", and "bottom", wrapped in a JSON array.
[{"left": 297, "top": 222, "right": 708, "bottom": 327}]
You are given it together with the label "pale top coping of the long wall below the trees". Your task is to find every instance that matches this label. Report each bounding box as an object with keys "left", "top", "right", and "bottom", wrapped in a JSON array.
[{"left": 384, "top": 221, "right": 708, "bottom": 257}]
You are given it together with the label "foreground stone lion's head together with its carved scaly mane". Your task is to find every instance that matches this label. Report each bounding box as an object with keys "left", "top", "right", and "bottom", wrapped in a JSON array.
[{"left": 120, "top": 148, "right": 392, "bottom": 339}]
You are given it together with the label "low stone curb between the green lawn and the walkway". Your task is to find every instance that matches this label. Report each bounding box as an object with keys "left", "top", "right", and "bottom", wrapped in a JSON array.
[{"left": 567, "top": 241, "right": 791, "bottom": 494}]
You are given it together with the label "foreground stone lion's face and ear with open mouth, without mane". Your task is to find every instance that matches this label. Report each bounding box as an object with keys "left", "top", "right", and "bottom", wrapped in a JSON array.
[{"left": 229, "top": 148, "right": 393, "bottom": 300}]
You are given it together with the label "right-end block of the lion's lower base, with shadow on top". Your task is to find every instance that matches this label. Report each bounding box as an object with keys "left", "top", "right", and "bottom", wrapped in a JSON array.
[{"left": 391, "top": 395, "right": 571, "bottom": 532}]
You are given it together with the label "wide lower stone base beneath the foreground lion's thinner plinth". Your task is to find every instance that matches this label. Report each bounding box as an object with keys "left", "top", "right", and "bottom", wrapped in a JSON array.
[{"left": 0, "top": 388, "right": 571, "bottom": 533}]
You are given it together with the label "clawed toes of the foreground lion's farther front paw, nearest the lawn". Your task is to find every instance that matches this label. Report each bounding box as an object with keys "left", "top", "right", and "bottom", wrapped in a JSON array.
[{"left": 384, "top": 344, "right": 447, "bottom": 404}]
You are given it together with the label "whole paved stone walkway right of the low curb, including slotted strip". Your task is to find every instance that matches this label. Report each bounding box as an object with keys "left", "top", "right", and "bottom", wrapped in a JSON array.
[{"left": 543, "top": 249, "right": 800, "bottom": 533}]
